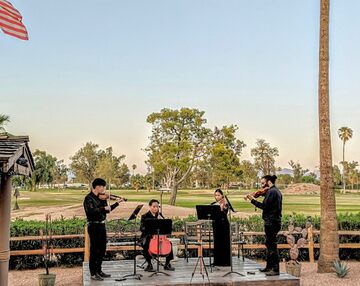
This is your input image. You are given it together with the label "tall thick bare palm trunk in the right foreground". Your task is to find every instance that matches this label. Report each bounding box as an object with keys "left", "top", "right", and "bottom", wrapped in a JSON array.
[{"left": 318, "top": 0, "right": 339, "bottom": 273}]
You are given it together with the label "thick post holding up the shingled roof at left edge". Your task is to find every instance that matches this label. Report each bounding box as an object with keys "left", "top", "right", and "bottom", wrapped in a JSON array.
[{"left": 0, "top": 174, "right": 11, "bottom": 286}]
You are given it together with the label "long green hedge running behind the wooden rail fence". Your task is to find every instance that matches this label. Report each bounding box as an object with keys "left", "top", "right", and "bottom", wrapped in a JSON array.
[{"left": 10, "top": 213, "right": 360, "bottom": 269}]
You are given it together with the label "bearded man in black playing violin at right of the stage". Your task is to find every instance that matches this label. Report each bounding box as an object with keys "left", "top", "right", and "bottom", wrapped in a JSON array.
[{"left": 247, "top": 175, "right": 282, "bottom": 276}]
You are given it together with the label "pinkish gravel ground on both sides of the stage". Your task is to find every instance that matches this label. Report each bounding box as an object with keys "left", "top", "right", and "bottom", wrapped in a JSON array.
[{"left": 9, "top": 262, "right": 360, "bottom": 286}]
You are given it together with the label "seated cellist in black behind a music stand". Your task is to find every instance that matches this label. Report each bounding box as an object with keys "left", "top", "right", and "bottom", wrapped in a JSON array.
[{"left": 140, "top": 199, "right": 175, "bottom": 271}]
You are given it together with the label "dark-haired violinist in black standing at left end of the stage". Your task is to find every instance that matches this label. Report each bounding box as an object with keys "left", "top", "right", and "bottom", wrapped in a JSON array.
[{"left": 84, "top": 178, "right": 123, "bottom": 281}]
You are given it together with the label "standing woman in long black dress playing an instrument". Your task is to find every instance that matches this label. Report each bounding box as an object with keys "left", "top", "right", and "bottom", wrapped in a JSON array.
[{"left": 212, "top": 189, "right": 231, "bottom": 266}]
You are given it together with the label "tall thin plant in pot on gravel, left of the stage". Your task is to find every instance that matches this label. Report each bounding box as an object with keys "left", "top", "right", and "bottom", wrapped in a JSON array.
[{"left": 38, "top": 214, "right": 56, "bottom": 286}]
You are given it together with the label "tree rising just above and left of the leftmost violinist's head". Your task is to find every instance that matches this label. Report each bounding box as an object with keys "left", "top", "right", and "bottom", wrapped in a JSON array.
[{"left": 70, "top": 142, "right": 101, "bottom": 190}]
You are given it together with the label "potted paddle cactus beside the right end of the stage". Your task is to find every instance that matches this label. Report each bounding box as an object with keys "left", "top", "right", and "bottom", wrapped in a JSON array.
[{"left": 285, "top": 218, "right": 311, "bottom": 277}]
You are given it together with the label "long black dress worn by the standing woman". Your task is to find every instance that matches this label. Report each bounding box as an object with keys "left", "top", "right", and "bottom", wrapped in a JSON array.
[{"left": 212, "top": 202, "right": 230, "bottom": 266}]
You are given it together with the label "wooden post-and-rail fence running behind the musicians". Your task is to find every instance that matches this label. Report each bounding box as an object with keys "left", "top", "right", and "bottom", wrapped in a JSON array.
[{"left": 10, "top": 227, "right": 360, "bottom": 262}]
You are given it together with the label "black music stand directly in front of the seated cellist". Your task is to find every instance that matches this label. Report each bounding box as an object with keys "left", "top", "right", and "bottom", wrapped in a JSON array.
[{"left": 144, "top": 218, "right": 172, "bottom": 277}]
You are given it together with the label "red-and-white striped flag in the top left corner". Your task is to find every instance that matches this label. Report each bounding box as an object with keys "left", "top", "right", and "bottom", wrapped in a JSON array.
[{"left": 0, "top": 0, "right": 29, "bottom": 40}]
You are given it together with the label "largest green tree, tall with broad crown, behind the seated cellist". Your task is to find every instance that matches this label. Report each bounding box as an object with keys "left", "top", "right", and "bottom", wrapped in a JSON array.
[{"left": 146, "top": 108, "right": 210, "bottom": 205}]
